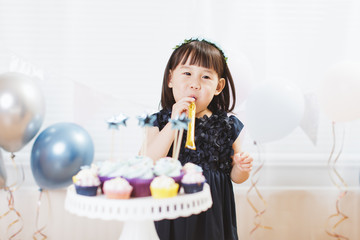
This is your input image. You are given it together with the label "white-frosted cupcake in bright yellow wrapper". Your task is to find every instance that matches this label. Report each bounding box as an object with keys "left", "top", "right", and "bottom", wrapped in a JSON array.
[{"left": 150, "top": 175, "right": 179, "bottom": 199}]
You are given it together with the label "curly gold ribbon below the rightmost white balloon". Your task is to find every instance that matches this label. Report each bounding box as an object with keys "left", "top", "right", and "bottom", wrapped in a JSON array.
[{"left": 325, "top": 122, "right": 349, "bottom": 240}]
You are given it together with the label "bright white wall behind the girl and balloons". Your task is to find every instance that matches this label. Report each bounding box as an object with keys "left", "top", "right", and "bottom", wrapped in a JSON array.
[{"left": 0, "top": 0, "right": 360, "bottom": 237}]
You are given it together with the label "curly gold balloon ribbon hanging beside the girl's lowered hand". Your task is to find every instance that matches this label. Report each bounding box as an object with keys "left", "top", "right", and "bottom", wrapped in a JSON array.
[{"left": 246, "top": 142, "right": 272, "bottom": 235}]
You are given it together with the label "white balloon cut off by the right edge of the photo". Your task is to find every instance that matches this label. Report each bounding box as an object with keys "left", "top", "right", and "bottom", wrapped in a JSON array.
[{"left": 318, "top": 62, "right": 360, "bottom": 122}]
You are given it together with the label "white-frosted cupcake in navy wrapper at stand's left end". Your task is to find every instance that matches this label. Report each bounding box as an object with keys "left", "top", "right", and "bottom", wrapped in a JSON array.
[{"left": 72, "top": 165, "right": 100, "bottom": 196}]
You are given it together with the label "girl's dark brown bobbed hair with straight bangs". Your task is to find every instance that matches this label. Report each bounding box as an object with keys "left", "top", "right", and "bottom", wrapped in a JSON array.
[{"left": 161, "top": 39, "right": 236, "bottom": 112}]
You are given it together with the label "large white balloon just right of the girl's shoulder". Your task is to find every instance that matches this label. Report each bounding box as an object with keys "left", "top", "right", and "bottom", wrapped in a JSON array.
[{"left": 245, "top": 82, "right": 305, "bottom": 143}]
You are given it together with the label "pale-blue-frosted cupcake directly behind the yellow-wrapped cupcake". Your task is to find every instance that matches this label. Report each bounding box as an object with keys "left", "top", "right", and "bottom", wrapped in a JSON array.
[{"left": 154, "top": 157, "right": 184, "bottom": 189}]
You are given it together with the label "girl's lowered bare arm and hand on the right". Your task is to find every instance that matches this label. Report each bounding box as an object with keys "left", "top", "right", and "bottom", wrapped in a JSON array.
[{"left": 230, "top": 135, "right": 253, "bottom": 183}]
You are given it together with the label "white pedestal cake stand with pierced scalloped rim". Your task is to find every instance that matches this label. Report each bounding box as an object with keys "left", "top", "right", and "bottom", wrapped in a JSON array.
[{"left": 65, "top": 184, "right": 212, "bottom": 240}]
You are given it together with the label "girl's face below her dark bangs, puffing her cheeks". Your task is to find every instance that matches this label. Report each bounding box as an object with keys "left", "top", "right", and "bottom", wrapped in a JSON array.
[{"left": 168, "top": 58, "right": 225, "bottom": 117}]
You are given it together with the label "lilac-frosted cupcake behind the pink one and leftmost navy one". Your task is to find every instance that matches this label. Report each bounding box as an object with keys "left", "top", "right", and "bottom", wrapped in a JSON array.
[{"left": 98, "top": 161, "right": 127, "bottom": 193}]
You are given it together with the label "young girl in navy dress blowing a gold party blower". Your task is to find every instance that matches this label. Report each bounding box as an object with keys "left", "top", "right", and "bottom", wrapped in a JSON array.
[{"left": 147, "top": 39, "right": 253, "bottom": 240}]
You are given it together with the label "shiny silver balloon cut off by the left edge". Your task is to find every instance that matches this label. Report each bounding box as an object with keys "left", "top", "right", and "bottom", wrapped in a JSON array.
[{"left": 0, "top": 72, "right": 45, "bottom": 152}]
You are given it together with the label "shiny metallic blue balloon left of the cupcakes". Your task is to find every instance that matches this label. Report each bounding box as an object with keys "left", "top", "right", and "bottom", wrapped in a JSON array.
[{"left": 31, "top": 123, "right": 94, "bottom": 189}]
